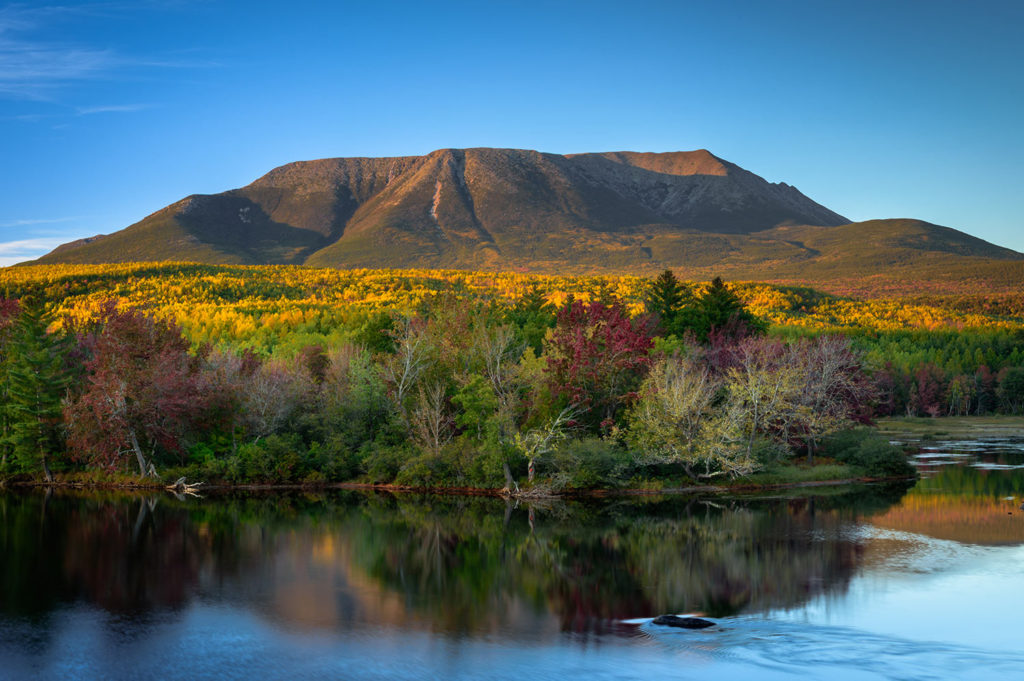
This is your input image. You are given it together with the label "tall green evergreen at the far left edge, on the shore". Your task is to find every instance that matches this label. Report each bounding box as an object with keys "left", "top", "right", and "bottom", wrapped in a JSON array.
[{"left": 4, "top": 300, "right": 71, "bottom": 481}]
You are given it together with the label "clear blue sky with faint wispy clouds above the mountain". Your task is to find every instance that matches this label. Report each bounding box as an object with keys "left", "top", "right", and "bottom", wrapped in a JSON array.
[{"left": 0, "top": 0, "right": 1024, "bottom": 264}]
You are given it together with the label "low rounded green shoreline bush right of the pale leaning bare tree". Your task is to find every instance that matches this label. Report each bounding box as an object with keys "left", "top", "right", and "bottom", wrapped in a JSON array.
[{"left": 551, "top": 437, "right": 633, "bottom": 490}]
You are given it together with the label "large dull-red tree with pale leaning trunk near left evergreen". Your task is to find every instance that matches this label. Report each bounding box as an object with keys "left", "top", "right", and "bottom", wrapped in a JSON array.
[{"left": 65, "top": 302, "right": 207, "bottom": 475}]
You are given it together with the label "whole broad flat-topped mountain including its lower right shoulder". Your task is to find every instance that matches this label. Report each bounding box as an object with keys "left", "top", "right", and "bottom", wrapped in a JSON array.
[{"left": 38, "top": 148, "right": 1024, "bottom": 292}]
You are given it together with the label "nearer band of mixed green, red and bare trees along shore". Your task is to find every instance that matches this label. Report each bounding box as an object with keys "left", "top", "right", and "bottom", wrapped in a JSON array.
[{"left": 0, "top": 271, "right": 958, "bottom": 491}]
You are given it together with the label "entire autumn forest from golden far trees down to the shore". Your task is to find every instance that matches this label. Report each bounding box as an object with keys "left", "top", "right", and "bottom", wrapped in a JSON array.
[{"left": 0, "top": 264, "right": 1024, "bottom": 494}]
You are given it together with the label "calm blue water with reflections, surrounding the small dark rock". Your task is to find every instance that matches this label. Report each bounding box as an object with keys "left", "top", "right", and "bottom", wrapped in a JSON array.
[{"left": 0, "top": 439, "right": 1024, "bottom": 681}]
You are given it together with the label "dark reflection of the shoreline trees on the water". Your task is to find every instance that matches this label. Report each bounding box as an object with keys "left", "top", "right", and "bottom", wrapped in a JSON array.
[{"left": 0, "top": 486, "right": 905, "bottom": 639}]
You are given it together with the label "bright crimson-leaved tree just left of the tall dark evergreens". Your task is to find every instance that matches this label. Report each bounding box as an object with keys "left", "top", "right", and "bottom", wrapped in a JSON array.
[{"left": 546, "top": 300, "right": 653, "bottom": 430}]
